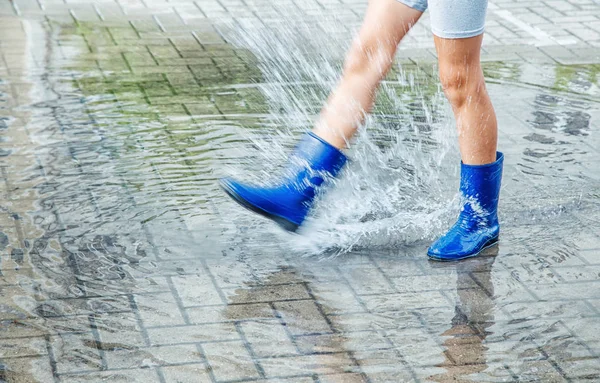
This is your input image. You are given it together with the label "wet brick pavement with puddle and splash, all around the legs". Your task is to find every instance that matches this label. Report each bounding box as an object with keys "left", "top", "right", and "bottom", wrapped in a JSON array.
[{"left": 0, "top": 0, "right": 600, "bottom": 382}]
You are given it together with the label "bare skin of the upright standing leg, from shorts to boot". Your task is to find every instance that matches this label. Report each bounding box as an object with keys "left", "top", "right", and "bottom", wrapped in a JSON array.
[{"left": 435, "top": 35, "right": 498, "bottom": 165}]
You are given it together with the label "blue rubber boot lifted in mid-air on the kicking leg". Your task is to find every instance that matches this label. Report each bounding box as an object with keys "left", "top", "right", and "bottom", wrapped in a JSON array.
[{"left": 221, "top": 133, "right": 346, "bottom": 231}]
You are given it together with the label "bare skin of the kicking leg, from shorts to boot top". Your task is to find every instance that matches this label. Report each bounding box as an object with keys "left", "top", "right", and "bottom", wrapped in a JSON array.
[{"left": 314, "top": 0, "right": 422, "bottom": 149}]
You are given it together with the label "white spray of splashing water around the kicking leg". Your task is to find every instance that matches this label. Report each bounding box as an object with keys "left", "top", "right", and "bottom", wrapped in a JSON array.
[{"left": 219, "top": 21, "right": 459, "bottom": 254}]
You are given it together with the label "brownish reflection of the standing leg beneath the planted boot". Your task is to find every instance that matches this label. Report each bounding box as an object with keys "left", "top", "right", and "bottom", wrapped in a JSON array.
[{"left": 431, "top": 246, "right": 498, "bottom": 382}]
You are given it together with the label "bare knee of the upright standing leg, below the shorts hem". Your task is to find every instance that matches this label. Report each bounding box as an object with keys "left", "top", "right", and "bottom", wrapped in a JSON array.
[{"left": 440, "top": 64, "right": 484, "bottom": 108}]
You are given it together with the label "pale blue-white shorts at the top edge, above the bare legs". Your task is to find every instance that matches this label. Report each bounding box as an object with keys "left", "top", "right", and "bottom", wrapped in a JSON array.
[{"left": 398, "top": 0, "right": 487, "bottom": 39}]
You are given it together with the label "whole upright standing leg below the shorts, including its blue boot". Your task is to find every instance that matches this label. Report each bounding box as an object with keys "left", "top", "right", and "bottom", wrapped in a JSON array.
[{"left": 427, "top": 32, "right": 504, "bottom": 261}]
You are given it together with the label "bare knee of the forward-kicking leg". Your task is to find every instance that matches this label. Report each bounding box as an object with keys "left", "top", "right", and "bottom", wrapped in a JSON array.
[{"left": 344, "top": 39, "right": 396, "bottom": 76}]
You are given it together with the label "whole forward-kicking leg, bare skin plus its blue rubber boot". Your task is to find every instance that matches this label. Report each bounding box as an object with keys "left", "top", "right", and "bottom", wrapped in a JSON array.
[{"left": 221, "top": 0, "right": 422, "bottom": 231}]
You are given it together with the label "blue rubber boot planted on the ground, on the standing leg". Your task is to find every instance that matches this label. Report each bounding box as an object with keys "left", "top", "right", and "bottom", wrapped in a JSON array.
[{"left": 427, "top": 152, "right": 504, "bottom": 261}]
